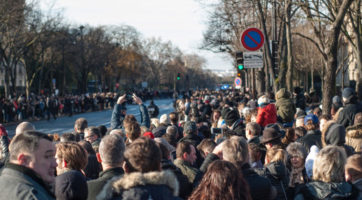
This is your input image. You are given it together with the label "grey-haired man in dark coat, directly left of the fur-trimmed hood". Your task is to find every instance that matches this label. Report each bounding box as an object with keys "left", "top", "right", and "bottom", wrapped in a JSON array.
[{"left": 87, "top": 135, "right": 125, "bottom": 200}]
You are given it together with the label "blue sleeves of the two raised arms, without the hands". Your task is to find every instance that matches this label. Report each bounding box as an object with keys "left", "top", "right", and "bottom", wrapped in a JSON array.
[{"left": 111, "top": 104, "right": 151, "bottom": 129}]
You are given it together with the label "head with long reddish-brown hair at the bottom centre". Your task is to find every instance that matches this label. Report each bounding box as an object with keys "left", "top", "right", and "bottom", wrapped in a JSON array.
[{"left": 189, "top": 160, "right": 251, "bottom": 200}]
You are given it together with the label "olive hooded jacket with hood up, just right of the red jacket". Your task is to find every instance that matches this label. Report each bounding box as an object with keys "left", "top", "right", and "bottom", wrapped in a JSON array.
[{"left": 275, "top": 88, "right": 296, "bottom": 122}]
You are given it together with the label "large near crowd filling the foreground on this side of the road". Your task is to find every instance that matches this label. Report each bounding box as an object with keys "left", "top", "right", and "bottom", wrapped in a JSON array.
[{"left": 0, "top": 88, "right": 362, "bottom": 200}]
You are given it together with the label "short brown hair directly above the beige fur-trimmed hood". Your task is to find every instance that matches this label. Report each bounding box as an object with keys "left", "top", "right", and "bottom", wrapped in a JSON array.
[{"left": 124, "top": 137, "right": 161, "bottom": 173}]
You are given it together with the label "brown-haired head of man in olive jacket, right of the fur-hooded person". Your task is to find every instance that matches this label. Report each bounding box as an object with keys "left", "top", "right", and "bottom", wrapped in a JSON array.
[{"left": 176, "top": 141, "right": 197, "bottom": 165}]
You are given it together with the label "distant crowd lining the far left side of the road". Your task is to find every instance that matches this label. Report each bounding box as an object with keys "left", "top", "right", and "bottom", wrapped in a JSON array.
[{"left": 0, "top": 90, "right": 173, "bottom": 124}]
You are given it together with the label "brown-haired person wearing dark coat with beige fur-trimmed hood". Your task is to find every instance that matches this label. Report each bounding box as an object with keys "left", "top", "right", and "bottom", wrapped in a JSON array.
[{"left": 97, "top": 137, "right": 179, "bottom": 200}]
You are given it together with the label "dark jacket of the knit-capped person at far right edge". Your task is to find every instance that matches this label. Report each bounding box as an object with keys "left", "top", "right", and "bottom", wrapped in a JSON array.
[{"left": 337, "top": 102, "right": 362, "bottom": 128}]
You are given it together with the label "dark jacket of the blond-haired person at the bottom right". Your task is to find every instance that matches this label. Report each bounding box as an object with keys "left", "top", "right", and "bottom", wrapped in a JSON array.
[{"left": 294, "top": 181, "right": 358, "bottom": 200}]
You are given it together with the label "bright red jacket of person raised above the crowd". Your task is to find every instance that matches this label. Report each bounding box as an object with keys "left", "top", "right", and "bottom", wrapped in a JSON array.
[{"left": 256, "top": 103, "right": 277, "bottom": 127}]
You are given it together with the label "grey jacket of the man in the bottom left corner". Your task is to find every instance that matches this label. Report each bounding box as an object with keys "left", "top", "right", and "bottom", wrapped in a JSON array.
[{"left": 0, "top": 163, "right": 55, "bottom": 200}]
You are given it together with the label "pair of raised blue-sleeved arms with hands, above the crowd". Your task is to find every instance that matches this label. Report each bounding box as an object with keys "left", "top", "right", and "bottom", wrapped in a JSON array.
[{"left": 111, "top": 94, "right": 150, "bottom": 130}]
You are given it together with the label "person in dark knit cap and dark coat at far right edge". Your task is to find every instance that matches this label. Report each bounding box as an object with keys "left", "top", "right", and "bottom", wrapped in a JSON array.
[{"left": 337, "top": 88, "right": 362, "bottom": 128}]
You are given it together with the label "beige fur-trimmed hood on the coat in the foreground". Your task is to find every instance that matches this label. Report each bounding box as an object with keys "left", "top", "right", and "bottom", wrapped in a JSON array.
[{"left": 97, "top": 170, "right": 179, "bottom": 199}]
